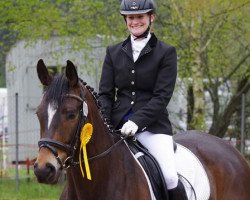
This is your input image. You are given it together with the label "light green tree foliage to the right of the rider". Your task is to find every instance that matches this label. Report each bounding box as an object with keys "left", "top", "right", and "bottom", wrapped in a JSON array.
[{"left": 156, "top": 0, "right": 250, "bottom": 78}]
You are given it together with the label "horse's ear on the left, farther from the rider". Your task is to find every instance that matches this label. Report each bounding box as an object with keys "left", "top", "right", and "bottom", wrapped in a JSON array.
[{"left": 36, "top": 59, "right": 52, "bottom": 86}]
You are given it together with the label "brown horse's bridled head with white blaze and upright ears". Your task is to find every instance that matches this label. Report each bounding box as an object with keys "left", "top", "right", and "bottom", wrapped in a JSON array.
[{"left": 34, "top": 60, "right": 98, "bottom": 184}]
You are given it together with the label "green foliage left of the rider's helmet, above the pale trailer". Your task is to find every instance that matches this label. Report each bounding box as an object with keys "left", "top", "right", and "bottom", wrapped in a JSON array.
[{"left": 0, "top": 0, "right": 125, "bottom": 45}]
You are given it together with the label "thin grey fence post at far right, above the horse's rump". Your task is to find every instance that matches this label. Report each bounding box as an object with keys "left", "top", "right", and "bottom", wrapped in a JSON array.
[{"left": 240, "top": 93, "right": 245, "bottom": 154}]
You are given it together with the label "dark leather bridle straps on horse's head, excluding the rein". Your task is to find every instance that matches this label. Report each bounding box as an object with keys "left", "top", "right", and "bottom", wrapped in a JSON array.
[{"left": 38, "top": 92, "right": 87, "bottom": 169}]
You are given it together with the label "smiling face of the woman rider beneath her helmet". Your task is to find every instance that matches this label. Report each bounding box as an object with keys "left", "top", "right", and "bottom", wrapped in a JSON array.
[{"left": 126, "top": 13, "right": 154, "bottom": 36}]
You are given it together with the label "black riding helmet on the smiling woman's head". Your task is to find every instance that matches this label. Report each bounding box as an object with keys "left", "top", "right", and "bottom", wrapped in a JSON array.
[{"left": 120, "top": 0, "right": 155, "bottom": 15}]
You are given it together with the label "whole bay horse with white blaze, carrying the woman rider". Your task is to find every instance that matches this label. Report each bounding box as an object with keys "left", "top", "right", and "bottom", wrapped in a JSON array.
[{"left": 34, "top": 60, "right": 250, "bottom": 200}]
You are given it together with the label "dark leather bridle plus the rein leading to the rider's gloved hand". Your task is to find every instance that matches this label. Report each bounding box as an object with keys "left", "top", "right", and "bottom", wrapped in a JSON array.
[{"left": 38, "top": 83, "right": 128, "bottom": 169}]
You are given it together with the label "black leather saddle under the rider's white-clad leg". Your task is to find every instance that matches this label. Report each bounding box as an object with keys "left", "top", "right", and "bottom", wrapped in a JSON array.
[{"left": 126, "top": 138, "right": 176, "bottom": 200}]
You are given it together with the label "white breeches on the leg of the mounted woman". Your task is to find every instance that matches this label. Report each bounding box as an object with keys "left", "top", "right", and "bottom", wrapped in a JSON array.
[{"left": 135, "top": 131, "right": 178, "bottom": 190}]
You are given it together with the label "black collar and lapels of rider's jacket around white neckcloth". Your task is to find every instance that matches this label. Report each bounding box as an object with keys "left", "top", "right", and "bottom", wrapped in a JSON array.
[{"left": 122, "top": 33, "right": 158, "bottom": 60}]
